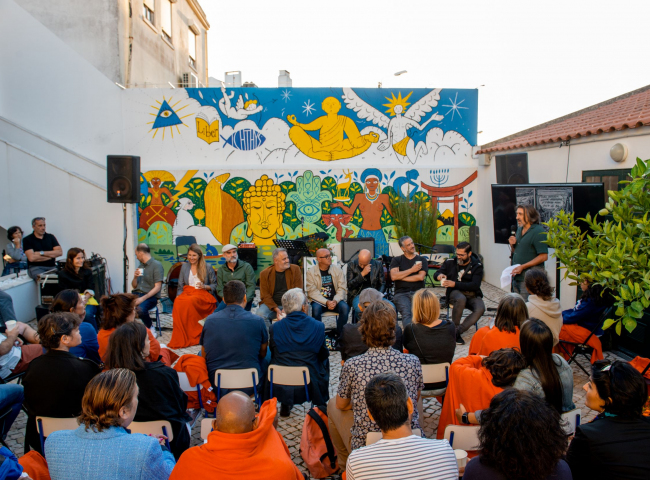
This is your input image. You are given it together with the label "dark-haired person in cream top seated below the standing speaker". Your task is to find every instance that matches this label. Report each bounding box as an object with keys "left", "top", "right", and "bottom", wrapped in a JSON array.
[{"left": 524, "top": 268, "right": 562, "bottom": 345}]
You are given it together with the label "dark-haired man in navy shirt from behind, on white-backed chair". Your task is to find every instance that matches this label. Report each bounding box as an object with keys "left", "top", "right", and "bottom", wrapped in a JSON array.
[{"left": 200, "top": 280, "right": 270, "bottom": 395}]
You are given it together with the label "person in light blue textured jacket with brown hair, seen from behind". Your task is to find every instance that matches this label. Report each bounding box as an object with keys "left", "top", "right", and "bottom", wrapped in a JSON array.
[{"left": 45, "top": 368, "right": 174, "bottom": 480}]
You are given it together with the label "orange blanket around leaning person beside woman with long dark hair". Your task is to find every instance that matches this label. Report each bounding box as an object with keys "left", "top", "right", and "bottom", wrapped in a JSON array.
[{"left": 437, "top": 355, "right": 503, "bottom": 439}]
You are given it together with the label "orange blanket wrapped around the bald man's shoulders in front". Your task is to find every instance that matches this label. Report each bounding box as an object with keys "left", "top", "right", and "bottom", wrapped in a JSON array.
[{"left": 169, "top": 398, "right": 304, "bottom": 480}]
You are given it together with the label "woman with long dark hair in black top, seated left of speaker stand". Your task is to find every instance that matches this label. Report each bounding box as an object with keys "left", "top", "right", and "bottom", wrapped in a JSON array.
[{"left": 57, "top": 248, "right": 99, "bottom": 333}]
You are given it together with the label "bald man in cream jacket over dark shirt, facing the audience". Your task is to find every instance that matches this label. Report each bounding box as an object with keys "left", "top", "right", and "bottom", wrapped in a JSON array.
[{"left": 305, "top": 248, "right": 350, "bottom": 336}]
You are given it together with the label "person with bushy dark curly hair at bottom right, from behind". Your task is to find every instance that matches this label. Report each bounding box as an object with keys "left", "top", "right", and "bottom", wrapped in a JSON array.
[{"left": 463, "top": 388, "right": 568, "bottom": 480}]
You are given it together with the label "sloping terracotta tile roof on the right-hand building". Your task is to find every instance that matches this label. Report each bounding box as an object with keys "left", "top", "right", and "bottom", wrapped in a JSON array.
[{"left": 477, "top": 85, "right": 650, "bottom": 153}]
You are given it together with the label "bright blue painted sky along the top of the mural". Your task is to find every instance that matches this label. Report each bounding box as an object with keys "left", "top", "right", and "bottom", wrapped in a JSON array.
[{"left": 186, "top": 87, "right": 478, "bottom": 145}]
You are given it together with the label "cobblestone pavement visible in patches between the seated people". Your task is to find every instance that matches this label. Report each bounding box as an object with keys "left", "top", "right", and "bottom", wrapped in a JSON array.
[{"left": 6, "top": 282, "right": 620, "bottom": 472}]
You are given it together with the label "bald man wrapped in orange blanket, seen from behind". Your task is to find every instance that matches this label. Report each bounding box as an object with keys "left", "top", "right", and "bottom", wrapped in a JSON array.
[{"left": 170, "top": 392, "right": 305, "bottom": 480}]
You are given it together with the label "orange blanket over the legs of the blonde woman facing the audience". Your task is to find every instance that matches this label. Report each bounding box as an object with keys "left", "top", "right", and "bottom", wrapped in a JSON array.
[{"left": 169, "top": 285, "right": 217, "bottom": 348}]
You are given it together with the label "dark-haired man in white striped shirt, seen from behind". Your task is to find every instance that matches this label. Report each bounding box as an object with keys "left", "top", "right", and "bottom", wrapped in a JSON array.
[{"left": 346, "top": 372, "right": 459, "bottom": 480}]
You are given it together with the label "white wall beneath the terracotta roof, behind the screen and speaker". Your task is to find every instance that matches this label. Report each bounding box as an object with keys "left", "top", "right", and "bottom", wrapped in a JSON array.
[{"left": 476, "top": 127, "right": 650, "bottom": 308}]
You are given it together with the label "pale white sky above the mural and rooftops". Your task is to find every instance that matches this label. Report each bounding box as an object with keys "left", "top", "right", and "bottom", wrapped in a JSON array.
[{"left": 199, "top": 0, "right": 650, "bottom": 145}]
